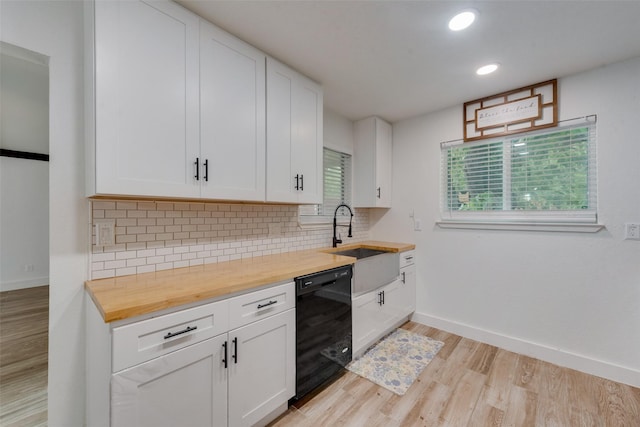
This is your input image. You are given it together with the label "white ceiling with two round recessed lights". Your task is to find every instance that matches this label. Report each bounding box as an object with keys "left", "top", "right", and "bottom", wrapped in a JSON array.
[{"left": 177, "top": 0, "right": 640, "bottom": 122}]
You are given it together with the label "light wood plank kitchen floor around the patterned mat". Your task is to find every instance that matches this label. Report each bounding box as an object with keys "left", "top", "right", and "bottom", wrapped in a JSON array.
[{"left": 270, "top": 322, "right": 640, "bottom": 427}]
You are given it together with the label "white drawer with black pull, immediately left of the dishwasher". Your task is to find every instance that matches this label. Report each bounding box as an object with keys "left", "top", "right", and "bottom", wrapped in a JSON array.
[{"left": 229, "top": 282, "right": 295, "bottom": 329}]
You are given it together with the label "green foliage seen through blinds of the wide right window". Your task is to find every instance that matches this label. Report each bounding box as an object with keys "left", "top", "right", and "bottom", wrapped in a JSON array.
[{"left": 443, "top": 127, "right": 589, "bottom": 211}]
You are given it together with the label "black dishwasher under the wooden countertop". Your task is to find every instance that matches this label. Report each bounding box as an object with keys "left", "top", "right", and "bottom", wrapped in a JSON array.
[{"left": 291, "top": 265, "right": 353, "bottom": 402}]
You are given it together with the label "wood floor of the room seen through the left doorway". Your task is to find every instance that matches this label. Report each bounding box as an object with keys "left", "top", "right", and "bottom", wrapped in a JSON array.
[{"left": 0, "top": 286, "right": 49, "bottom": 427}]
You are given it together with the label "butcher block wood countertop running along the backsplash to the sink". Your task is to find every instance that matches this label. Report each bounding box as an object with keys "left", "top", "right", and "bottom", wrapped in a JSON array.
[{"left": 85, "top": 241, "right": 415, "bottom": 322}]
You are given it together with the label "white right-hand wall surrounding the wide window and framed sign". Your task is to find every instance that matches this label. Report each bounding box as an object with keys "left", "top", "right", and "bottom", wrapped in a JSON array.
[{"left": 371, "top": 58, "right": 640, "bottom": 386}]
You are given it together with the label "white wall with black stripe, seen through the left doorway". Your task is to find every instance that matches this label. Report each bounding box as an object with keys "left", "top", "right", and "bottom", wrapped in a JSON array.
[{"left": 0, "top": 44, "right": 49, "bottom": 291}]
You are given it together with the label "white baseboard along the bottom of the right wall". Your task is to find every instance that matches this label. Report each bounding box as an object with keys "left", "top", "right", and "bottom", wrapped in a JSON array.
[{"left": 411, "top": 312, "right": 640, "bottom": 387}]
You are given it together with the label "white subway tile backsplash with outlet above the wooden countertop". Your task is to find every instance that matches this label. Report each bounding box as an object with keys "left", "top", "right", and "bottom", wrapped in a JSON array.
[{"left": 90, "top": 200, "right": 369, "bottom": 279}]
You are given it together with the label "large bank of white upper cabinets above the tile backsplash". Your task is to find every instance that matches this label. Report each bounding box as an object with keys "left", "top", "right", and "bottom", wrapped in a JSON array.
[{"left": 86, "top": 0, "right": 323, "bottom": 204}]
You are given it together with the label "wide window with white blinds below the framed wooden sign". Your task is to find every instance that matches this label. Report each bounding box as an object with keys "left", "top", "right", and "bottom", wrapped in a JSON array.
[{"left": 441, "top": 116, "right": 596, "bottom": 223}]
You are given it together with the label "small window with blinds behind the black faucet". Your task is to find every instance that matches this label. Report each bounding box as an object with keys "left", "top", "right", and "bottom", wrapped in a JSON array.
[{"left": 300, "top": 148, "right": 351, "bottom": 220}]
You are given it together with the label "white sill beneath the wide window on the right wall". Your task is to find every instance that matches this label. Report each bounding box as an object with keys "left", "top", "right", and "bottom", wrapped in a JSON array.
[{"left": 436, "top": 221, "right": 605, "bottom": 233}]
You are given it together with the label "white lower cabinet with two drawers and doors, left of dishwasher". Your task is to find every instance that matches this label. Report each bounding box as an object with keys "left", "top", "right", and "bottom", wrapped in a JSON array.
[{"left": 87, "top": 283, "right": 296, "bottom": 427}]
